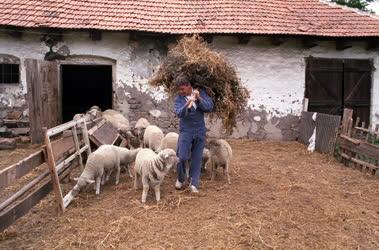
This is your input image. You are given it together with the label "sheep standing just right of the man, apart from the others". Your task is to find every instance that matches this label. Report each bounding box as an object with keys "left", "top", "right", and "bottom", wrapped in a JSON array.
[{"left": 209, "top": 139, "right": 232, "bottom": 185}]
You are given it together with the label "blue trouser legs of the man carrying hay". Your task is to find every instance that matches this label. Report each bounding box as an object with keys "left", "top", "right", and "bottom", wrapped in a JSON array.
[{"left": 177, "top": 132, "right": 205, "bottom": 187}]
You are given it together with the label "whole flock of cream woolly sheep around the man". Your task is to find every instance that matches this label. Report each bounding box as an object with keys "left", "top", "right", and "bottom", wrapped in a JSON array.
[{"left": 70, "top": 106, "right": 232, "bottom": 203}]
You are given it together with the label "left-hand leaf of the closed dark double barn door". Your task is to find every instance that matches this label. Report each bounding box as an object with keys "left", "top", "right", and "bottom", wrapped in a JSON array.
[{"left": 305, "top": 57, "right": 343, "bottom": 115}]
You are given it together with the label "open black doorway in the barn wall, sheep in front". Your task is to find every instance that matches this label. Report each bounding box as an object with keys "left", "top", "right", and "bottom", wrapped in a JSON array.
[{"left": 62, "top": 65, "right": 112, "bottom": 122}]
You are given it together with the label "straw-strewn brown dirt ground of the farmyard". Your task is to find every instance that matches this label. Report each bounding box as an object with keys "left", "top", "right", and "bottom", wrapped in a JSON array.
[{"left": 0, "top": 140, "right": 379, "bottom": 249}]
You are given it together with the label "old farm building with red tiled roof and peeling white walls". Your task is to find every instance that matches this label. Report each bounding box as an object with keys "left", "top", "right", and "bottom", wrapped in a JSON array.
[{"left": 0, "top": 0, "right": 379, "bottom": 142}]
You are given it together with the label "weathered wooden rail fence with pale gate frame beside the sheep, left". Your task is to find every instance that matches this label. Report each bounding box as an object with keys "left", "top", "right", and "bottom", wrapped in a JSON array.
[{"left": 0, "top": 117, "right": 120, "bottom": 231}]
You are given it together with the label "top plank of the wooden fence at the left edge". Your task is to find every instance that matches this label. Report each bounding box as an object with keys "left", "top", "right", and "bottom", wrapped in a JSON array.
[{"left": 0, "top": 149, "right": 45, "bottom": 191}]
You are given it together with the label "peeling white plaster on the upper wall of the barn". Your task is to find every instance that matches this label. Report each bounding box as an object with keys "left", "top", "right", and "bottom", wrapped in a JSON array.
[{"left": 0, "top": 32, "right": 379, "bottom": 136}]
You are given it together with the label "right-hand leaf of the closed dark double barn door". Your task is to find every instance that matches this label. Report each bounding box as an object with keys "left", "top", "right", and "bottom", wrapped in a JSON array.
[{"left": 343, "top": 59, "right": 373, "bottom": 124}]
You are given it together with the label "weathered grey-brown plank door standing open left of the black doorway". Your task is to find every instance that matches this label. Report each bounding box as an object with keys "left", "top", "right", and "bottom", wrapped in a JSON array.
[{"left": 25, "top": 59, "right": 60, "bottom": 143}]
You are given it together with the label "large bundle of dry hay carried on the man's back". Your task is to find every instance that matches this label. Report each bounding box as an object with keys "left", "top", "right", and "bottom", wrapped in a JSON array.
[{"left": 149, "top": 36, "right": 249, "bottom": 133}]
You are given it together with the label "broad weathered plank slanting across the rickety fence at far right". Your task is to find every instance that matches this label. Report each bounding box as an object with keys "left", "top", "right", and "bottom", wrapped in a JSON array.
[{"left": 338, "top": 135, "right": 379, "bottom": 160}]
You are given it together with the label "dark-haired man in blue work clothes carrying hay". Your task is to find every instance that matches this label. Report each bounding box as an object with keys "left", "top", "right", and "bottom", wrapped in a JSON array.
[{"left": 174, "top": 76, "right": 213, "bottom": 193}]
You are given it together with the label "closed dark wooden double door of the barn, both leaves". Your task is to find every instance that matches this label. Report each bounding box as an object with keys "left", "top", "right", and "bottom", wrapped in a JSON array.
[{"left": 305, "top": 57, "right": 373, "bottom": 124}]
